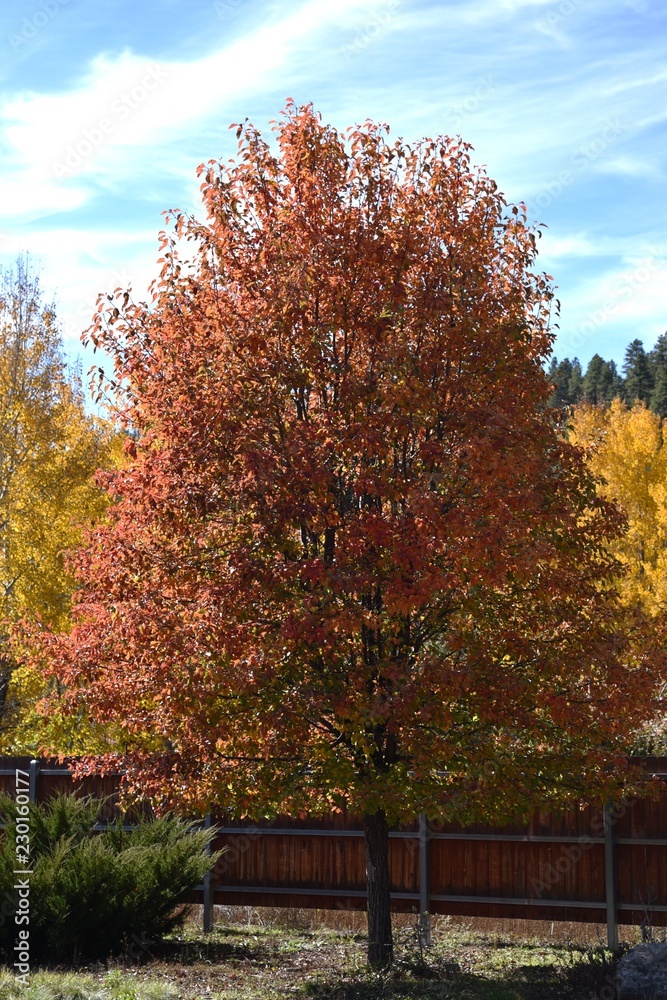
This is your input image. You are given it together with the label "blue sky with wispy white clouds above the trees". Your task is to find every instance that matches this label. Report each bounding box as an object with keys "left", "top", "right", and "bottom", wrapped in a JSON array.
[{"left": 0, "top": 0, "right": 667, "bottom": 382}]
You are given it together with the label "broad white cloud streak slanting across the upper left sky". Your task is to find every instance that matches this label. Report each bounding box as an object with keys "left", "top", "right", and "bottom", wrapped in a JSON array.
[{"left": 0, "top": 0, "right": 391, "bottom": 219}]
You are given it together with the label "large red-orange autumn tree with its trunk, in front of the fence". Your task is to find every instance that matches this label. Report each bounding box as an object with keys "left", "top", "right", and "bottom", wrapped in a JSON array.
[{"left": 35, "top": 104, "right": 662, "bottom": 966}]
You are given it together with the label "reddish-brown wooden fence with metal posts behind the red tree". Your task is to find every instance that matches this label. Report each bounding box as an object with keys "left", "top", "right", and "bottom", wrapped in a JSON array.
[{"left": 0, "top": 757, "right": 667, "bottom": 946}]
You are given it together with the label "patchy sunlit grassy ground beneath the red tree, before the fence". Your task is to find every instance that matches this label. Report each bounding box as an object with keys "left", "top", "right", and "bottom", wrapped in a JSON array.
[{"left": 0, "top": 907, "right": 639, "bottom": 1000}]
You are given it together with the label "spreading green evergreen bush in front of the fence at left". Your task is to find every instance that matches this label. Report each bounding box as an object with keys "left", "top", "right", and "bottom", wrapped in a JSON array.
[{"left": 0, "top": 795, "right": 220, "bottom": 965}]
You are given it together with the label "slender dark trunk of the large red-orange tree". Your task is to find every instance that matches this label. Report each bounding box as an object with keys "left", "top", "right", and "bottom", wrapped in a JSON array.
[{"left": 363, "top": 810, "right": 394, "bottom": 969}]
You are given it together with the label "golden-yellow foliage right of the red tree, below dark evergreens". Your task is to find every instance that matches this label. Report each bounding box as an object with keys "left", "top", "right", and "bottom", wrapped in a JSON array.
[{"left": 570, "top": 399, "right": 667, "bottom": 614}]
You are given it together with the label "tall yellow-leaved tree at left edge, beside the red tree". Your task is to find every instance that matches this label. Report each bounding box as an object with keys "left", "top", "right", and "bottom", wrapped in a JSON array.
[{"left": 0, "top": 258, "right": 115, "bottom": 752}]
